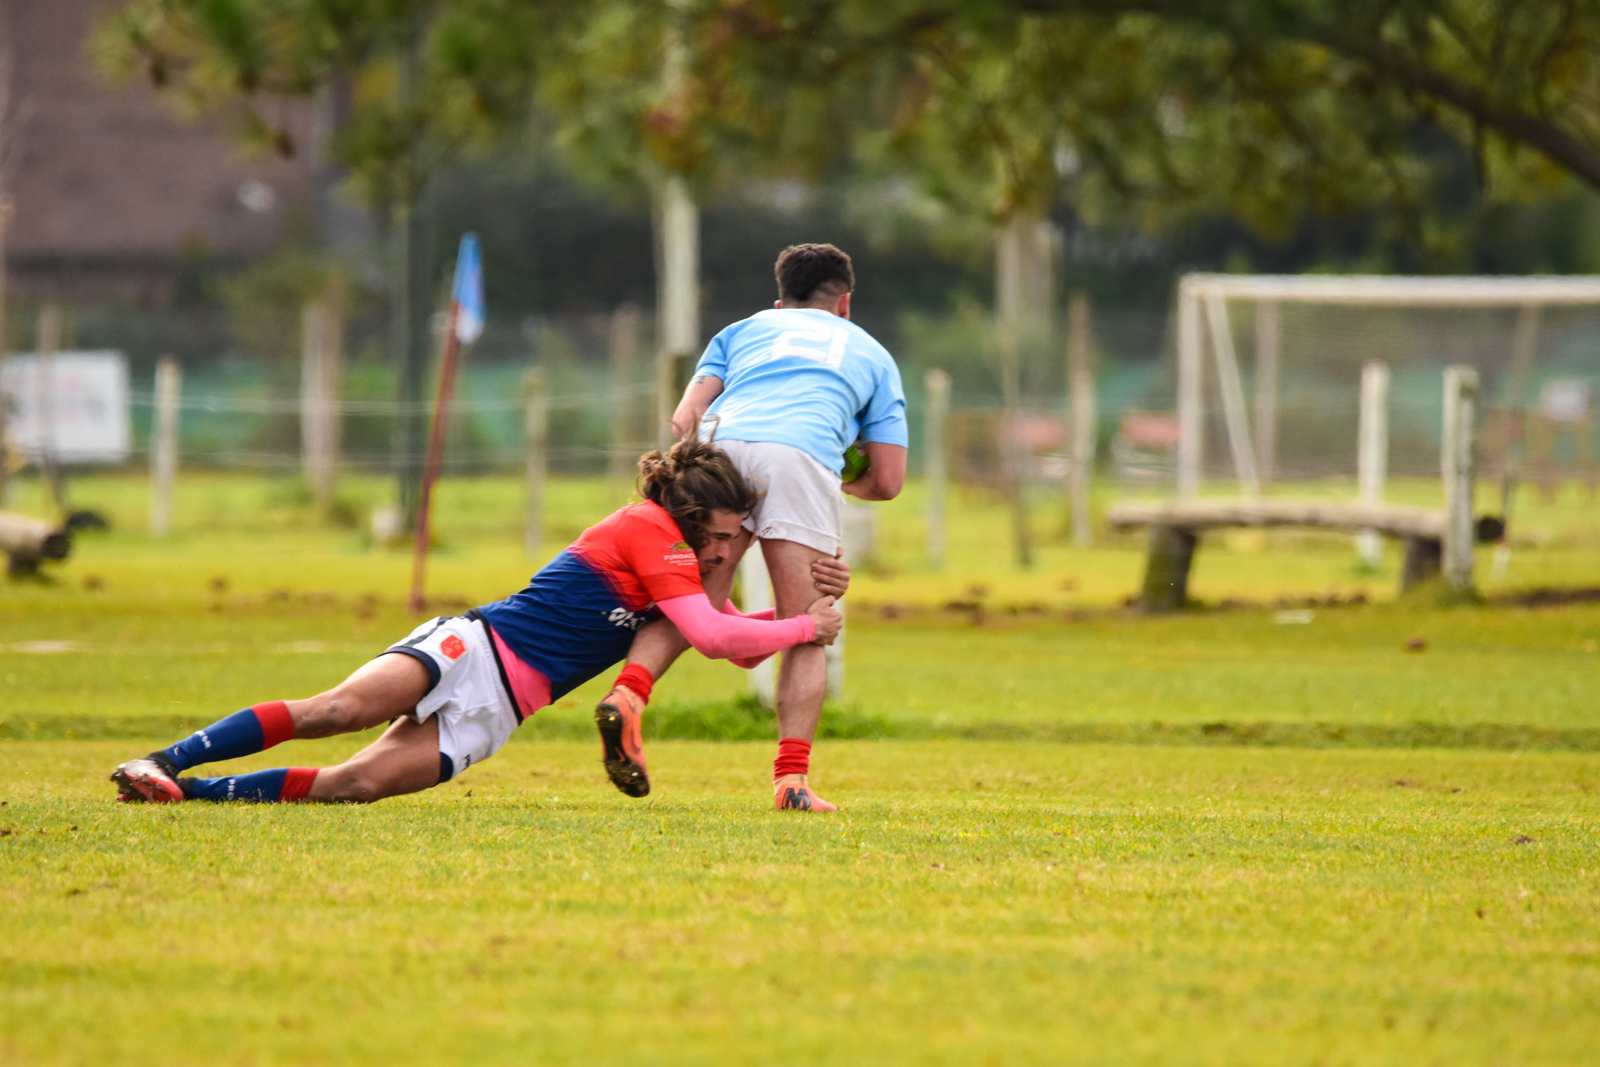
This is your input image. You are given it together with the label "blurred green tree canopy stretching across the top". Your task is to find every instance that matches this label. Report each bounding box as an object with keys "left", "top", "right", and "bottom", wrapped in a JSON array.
[{"left": 99, "top": 0, "right": 1600, "bottom": 255}]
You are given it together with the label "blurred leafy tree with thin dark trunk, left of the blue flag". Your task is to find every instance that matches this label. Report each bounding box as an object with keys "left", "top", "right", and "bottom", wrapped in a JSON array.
[{"left": 93, "top": 0, "right": 565, "bottom": 515}]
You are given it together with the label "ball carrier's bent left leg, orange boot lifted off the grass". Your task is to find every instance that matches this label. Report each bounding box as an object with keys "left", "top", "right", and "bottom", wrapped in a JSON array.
[{"left": 595, "top": 530, "right": 750, "bottom": 797}]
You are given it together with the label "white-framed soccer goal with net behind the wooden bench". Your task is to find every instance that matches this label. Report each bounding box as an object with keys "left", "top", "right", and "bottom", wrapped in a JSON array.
[{"left": 1174, "top": 274, "right": 1600, "bottom": 499}]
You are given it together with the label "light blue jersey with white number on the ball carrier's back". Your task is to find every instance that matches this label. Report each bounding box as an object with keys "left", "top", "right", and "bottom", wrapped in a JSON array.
[{"left": 694, "top": 307, "right": 907, "bottom": 474}]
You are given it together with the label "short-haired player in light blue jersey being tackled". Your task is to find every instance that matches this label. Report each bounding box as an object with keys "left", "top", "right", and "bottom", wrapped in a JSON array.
[{"left": 614, "top": 245, "right": 907, "bottom": 811}]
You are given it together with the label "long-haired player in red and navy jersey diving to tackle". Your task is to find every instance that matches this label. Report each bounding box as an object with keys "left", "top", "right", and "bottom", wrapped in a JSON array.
[{"left": 112, "top": 440, "right": 848, "bottom": 801}]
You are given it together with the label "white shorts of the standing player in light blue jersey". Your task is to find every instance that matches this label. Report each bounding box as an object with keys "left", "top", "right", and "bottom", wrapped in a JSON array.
[{"left": 715, "top": 440, "right": 845, "bottom": 555}]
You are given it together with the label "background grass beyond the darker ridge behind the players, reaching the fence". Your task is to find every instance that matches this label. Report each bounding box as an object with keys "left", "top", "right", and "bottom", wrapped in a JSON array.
[{"left": 0, "top": 475, "right": 1600, "bottom": 749}]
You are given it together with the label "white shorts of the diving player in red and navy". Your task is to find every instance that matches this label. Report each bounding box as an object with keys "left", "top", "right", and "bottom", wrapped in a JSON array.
[{"left": 387, "top": 613, "right": 522, "bottom": 782}]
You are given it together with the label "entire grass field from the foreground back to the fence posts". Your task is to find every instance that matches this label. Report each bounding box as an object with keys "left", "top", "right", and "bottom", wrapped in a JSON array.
[{"left": 0, "top": 475, "right": 1600, "bottom": 1064}]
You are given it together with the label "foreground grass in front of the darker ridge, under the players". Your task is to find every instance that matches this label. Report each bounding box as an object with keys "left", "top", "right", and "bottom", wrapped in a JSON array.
[{"left": 0, "top": 742, "right": 1600, "bottom": 1064}]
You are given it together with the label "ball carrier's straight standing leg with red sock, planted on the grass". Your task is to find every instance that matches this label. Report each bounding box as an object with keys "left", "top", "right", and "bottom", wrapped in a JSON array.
[{"left": 762, "top": 539, "right": 834, "bottom": 811}]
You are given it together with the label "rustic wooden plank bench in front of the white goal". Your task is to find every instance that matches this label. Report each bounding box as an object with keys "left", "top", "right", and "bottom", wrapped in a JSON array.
[{"left": 1106, "top": 501, "right": 1499, "bottom": 613}]
